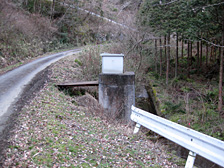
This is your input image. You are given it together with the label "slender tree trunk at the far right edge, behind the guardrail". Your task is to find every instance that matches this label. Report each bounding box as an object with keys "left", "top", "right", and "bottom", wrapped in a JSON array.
[{"left": 218, "top": 21, "right": 224, "bottom": 113}]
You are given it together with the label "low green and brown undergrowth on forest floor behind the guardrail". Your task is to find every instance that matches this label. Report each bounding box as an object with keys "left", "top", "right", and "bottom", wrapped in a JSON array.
[{"left": 147, "top": 73, "right": 224, "bottom": 140}]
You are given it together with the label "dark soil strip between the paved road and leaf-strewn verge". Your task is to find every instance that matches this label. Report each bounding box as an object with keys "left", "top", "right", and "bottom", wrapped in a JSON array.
[{"left": 0, "top": 67, "right": 51, "bottom": 167}]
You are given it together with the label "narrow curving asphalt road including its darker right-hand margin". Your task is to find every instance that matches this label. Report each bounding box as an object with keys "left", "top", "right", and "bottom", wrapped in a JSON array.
[{"left": 0, "top": 49, "right": 80, "bottom": 134}]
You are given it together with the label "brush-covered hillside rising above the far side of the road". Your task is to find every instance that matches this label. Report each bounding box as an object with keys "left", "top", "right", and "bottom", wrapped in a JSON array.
[{"left": 0, "top": 0, "right": 139, "bottom": 69}]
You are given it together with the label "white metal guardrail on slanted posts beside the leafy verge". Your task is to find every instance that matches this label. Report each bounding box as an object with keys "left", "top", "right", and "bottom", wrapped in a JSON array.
[{"left": 131, "top": 106, "right": 224, "bottom": 168}]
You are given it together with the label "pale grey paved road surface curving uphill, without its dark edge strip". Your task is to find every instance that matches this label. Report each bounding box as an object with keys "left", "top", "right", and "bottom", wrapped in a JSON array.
[{"left": 0, "top": 49, "right": 80, "bottom": 134}]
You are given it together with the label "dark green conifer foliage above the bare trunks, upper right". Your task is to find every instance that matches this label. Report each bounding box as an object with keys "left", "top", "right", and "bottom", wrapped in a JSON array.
[{"left": 138, "top": 0, "right": 224, "bottom": 41}]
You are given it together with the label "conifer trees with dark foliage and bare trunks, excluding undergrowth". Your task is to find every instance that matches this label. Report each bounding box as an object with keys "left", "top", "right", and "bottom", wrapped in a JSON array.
[{"left": 139, "top": 0, "right": 224, "bottom": 112}]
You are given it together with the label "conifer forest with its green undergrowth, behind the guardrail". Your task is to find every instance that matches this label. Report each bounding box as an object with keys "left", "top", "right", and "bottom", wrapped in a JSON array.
[{"left": 131, "top": 0, "right": 224, "bottom": 140}]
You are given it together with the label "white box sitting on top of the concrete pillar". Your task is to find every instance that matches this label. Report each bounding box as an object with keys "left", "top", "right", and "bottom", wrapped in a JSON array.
[{"left": 100, "top": 53, "right": 124, "bottom": 74}]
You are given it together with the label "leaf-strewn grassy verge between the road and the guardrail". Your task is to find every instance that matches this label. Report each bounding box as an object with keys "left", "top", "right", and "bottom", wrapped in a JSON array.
[{"left": 0, "top": 52, "right": 182, "bottom": 167}]
